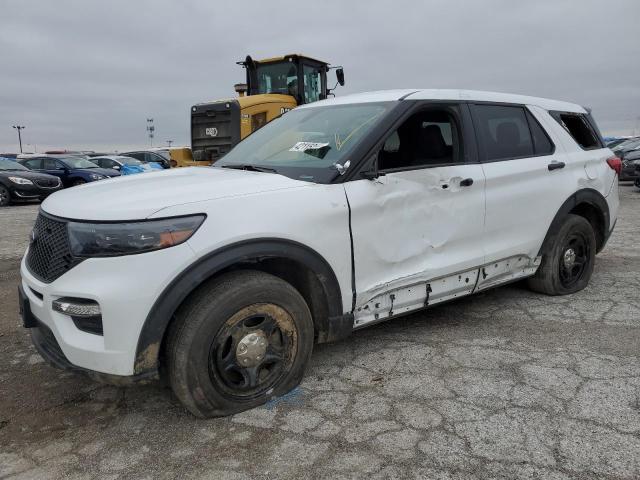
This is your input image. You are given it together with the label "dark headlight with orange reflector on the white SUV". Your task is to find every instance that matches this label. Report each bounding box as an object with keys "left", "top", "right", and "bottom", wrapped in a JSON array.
[{"left": 67, "top": 214, "right": 206, "bottom": 257}]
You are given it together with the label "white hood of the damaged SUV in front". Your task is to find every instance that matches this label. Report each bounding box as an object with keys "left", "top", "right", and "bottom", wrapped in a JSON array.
[{"left": 42, "top": 167, "right": 313, "bottom": 221}]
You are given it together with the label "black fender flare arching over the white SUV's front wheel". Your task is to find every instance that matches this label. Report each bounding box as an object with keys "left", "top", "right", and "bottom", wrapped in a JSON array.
[{"left": 134, "top": 238, "right": 353, "bottom": 375}]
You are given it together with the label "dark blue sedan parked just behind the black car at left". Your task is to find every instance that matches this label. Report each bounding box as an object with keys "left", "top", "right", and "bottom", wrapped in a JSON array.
[{"left": 18, "top": 155, "right": 120, "bottom": 188}]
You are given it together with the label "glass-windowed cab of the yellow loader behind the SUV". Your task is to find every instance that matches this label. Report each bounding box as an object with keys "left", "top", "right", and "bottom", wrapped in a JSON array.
[{"left": 238, "top": 54, "right": 329, "bottom": 105}]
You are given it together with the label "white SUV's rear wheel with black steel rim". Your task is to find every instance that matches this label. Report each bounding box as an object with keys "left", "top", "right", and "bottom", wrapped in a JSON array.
[{"left": 528, "top": 214, "right": 596, "bottom": 295}]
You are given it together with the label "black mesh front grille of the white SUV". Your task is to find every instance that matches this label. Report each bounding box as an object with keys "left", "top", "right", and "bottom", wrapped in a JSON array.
[{"left": 27, "top": 212, "right": 81, "bottom": 283}]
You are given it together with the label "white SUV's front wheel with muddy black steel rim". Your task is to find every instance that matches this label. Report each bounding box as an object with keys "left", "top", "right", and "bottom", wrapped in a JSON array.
[{"left": 165, "top": 270, "right": 314, "bottom": 417}]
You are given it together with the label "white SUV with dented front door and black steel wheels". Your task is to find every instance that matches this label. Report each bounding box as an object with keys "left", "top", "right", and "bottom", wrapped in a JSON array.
[{"left": 20, "top": 90, "right": 621, "bottom": 416}]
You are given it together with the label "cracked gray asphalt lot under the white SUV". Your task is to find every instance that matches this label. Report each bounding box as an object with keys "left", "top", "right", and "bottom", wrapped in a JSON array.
[{"left": 0, "top": 185, "right": 640, "bottom": 480}]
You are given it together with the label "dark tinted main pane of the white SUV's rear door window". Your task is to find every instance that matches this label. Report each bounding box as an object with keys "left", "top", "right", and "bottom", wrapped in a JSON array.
[{"left": 474, "top": 105, "right": 534, "bottom": 161}]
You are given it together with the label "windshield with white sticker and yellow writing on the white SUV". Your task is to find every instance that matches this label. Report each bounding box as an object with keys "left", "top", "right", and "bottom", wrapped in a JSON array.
[{"left": 215, "top": 102, "right": 395, "bottom": 183}]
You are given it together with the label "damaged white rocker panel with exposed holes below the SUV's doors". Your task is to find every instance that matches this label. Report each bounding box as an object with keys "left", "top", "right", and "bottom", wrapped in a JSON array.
[{"left": 353, "top": 255, "right": 541, "bottom": 329}]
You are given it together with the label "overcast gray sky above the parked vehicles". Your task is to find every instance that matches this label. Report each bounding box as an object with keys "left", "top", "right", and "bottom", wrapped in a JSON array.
[{"left": 0, "top": 0, "right": 640, "bottom": 152}]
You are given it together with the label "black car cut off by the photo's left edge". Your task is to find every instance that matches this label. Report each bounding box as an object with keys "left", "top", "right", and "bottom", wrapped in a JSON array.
[{"left": 0, "top": 158, "right": 62, "bottom": 207}]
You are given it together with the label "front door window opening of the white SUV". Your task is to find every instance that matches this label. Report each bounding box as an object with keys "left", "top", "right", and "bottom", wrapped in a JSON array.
[{"left": 378, "top": 108, "right": 463, "bottom": 170}]
